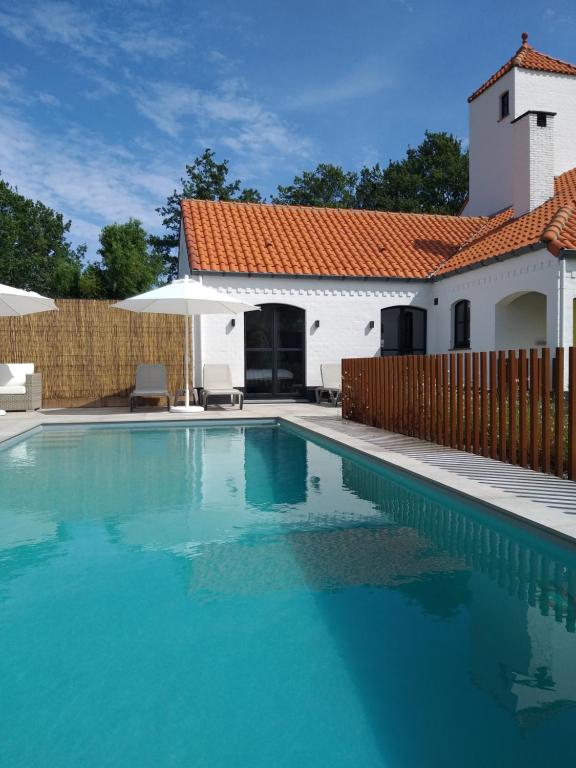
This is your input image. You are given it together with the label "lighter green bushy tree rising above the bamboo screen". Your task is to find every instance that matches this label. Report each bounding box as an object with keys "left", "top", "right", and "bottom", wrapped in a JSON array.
[{"left": 80, "top": 219, "right": 162, "bottom": 299}]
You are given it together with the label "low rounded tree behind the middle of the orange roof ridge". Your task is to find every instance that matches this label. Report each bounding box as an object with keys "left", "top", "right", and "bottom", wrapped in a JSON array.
[{"left": 272, "top": 163, "right": 358, "bottom": 208}]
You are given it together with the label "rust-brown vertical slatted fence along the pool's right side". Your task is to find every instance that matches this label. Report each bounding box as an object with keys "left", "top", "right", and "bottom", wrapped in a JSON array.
[{"left": 342, "top": 347, "right": 576, "bottom": 480}]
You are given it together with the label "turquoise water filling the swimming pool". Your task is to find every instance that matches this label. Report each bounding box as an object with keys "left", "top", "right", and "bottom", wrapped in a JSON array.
[{"left": 0, "top": 425, "right": 576, "bottom": 768}]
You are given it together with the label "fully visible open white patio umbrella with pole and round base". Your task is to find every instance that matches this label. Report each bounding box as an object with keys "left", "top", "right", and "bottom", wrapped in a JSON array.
[{"left": 114, "top": 276, "right": 260, "bottom": 413}]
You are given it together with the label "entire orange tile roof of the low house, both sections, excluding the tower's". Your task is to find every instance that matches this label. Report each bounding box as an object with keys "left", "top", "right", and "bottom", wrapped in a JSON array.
[{"left": 182, "top": 168, "right": 576, "bottom": 279}]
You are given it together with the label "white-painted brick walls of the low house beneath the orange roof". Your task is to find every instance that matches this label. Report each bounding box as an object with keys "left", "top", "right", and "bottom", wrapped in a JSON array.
[{"left": 179, "top": 243, "right": 576, "bottom": 387}]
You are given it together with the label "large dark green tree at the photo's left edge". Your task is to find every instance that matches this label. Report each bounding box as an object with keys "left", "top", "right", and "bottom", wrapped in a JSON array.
[{"left": 0, "top": 179, "right": 86, "bottom": 297}]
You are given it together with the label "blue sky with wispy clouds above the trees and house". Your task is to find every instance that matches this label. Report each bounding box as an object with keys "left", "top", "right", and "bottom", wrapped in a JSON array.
[{"left": 0, "top": 0, "right": 576, "bottom": 258}]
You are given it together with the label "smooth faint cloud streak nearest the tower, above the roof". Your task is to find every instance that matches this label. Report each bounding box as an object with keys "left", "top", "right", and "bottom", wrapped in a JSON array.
[{"left": 287, "top": 58, "right": 392, "bottom": 109}]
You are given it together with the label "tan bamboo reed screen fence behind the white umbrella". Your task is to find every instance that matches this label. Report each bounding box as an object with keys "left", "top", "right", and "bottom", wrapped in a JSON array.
[{"left": 0, "top": 299, "right": 184, "bottom": 408}]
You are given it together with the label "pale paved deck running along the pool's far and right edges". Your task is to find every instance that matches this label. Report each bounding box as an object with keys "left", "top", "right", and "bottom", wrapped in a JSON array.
[{"left": 0, "top": 403, "right": 576, "bottom": 543}]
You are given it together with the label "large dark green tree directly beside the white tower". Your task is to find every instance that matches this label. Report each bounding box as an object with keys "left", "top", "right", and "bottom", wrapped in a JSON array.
[{"left": 356, "top": 131, "right": 468, "bottom": 214}]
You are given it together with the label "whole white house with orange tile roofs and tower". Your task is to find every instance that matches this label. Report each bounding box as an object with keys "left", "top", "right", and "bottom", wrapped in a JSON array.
[{"left": 179, "top": 35, "right": 576, "bottom": 398}]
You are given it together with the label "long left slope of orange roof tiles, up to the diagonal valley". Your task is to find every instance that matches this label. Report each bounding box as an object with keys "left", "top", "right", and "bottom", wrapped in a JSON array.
[{"left": 182, "top": 200, "right": 486, "bottom": 278}]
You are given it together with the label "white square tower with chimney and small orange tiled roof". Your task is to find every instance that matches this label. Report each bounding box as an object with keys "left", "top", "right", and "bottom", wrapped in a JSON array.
[{"left": 464, "top": 33, "right": 576, "bottom": 216}]
